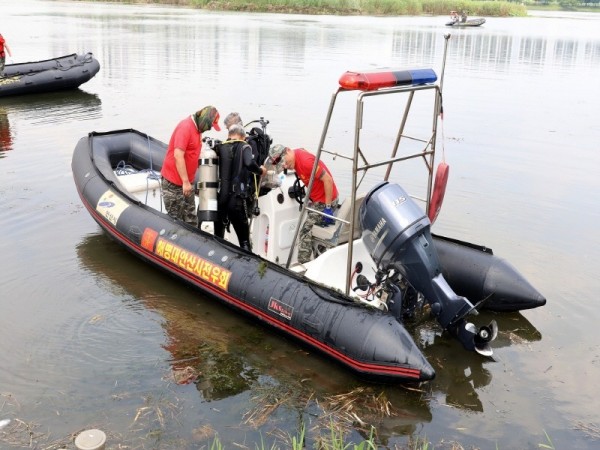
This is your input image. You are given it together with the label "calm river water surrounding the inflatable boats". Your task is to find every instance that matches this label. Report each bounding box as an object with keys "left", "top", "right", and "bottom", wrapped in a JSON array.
[{"left": 0, "top": 0, "right": 600, "bottom": 449}]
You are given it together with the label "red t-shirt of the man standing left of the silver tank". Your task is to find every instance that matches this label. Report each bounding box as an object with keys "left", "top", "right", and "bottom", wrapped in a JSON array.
[{"left": 160, "top": 117, "right": 202, "bottom": 186}]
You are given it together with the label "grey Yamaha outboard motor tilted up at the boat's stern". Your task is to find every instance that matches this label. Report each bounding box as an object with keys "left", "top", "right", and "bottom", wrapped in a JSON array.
[{"left": 359, "top": 182, "right": 497, "bottom": 356}]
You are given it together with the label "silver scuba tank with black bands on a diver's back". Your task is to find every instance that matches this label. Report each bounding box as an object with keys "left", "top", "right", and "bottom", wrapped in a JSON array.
[{"left": 197, "top": 138, "right": 219, "bottom": 224}]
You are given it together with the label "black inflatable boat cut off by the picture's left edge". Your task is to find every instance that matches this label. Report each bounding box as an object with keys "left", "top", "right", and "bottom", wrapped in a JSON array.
[{"left": 0, "top": 53, "right": 100, "bottom": 97}]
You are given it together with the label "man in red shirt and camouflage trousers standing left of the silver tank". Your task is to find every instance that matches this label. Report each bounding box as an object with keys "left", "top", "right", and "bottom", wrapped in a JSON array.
[{"left": 161, "top": 106, "right": 221, "bottom": 226}]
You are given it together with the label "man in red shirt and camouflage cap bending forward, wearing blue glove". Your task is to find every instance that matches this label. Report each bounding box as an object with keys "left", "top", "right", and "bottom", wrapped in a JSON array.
[{"left": 269, "top": 144, "right": 338, "bottom": 264}]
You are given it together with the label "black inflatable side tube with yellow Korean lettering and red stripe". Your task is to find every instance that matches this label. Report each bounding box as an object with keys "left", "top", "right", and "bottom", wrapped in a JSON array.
[{"left": 72, "top": 130, "right": 435, "bottom": 382}]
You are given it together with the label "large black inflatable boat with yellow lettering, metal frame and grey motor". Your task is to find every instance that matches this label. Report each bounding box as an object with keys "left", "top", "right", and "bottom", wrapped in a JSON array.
[{"left": 72, "top": 35, "right": 546, "bottom": 382}]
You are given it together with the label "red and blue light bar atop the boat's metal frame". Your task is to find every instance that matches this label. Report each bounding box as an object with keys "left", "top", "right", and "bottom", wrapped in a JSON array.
[{"left": 340, "top": 69, "right": 437, "bottom": 91}]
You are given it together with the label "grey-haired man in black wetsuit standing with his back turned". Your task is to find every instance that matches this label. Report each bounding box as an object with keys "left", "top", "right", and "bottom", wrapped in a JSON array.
[{"left": 215, "top": 124, "right": 267, "bottom": 251}]
